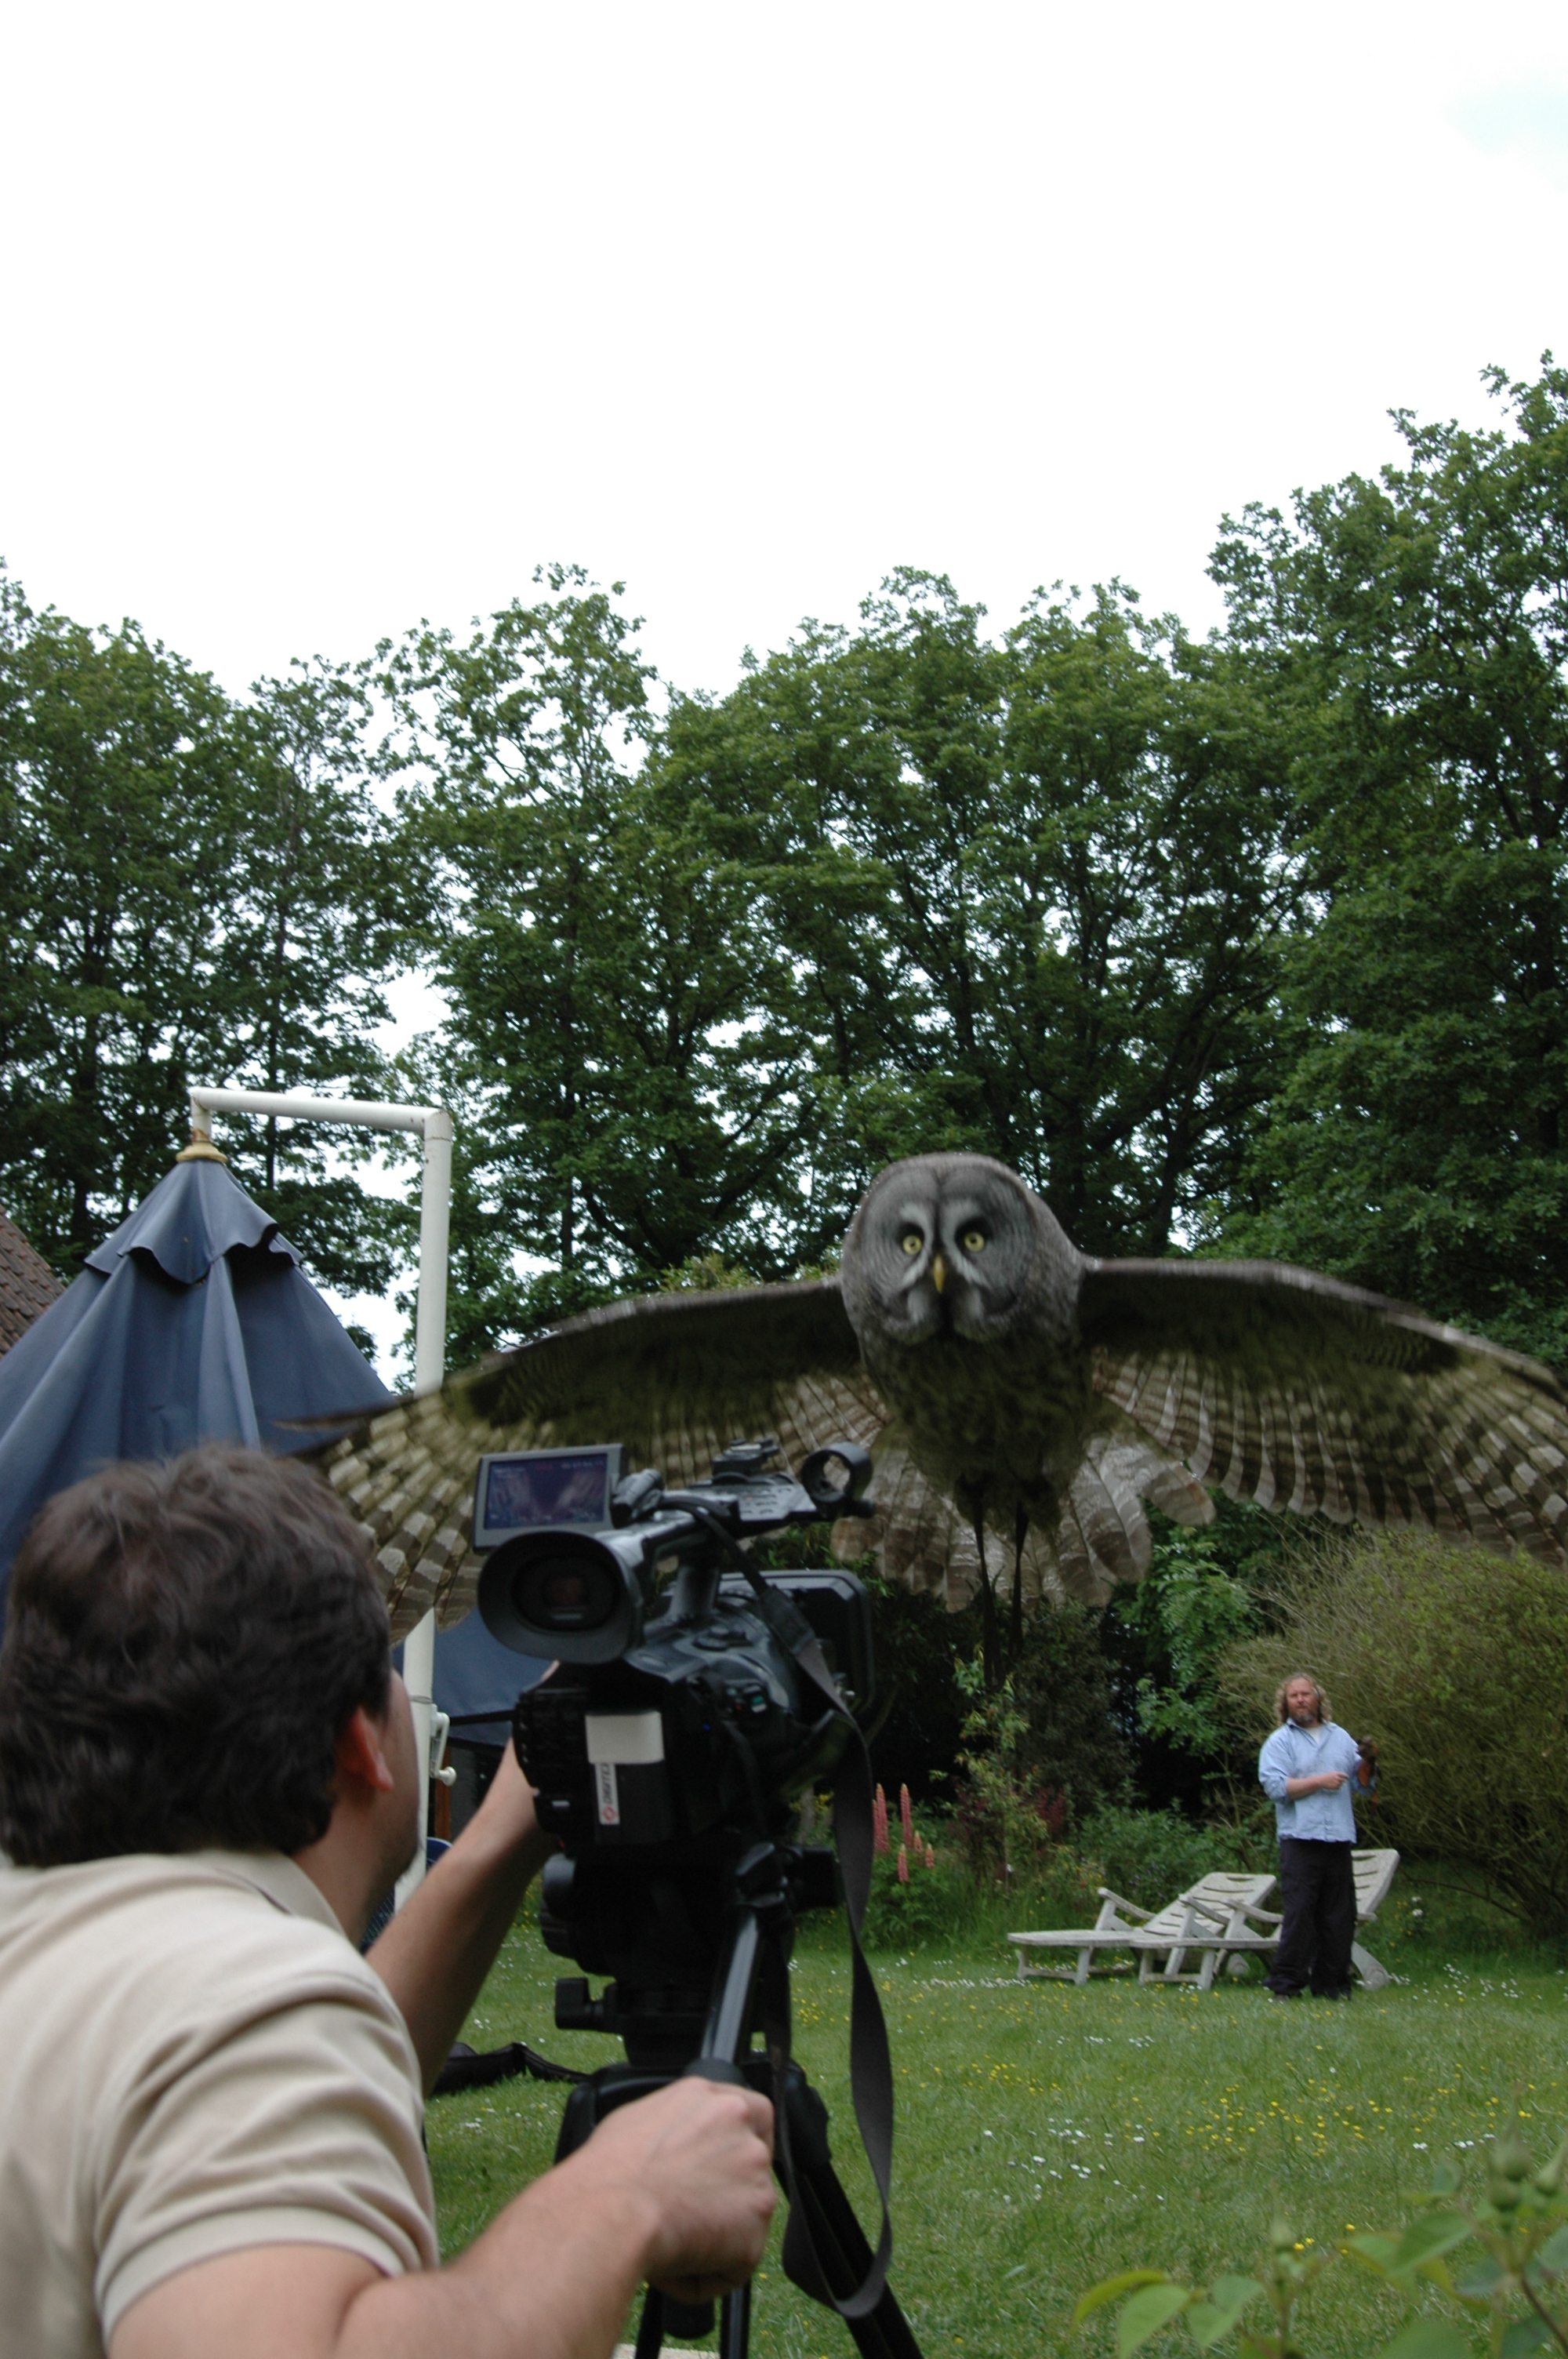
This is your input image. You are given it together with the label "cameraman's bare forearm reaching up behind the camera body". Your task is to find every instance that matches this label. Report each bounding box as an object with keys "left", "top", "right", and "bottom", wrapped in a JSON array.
[{"left": 368, "top": 1746, "right": 552, "bottom": 2095}]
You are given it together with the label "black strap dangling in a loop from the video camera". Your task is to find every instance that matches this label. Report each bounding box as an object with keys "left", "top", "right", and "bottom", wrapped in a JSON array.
[{"left": 695, "top": 1510, "right": 894, "bottom": 2319}]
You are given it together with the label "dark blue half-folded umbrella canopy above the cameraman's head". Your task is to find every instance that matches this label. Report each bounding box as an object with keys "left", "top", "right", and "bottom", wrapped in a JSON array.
[{"left": 0, "top": 1156, "right": 391, "bottom": 1606}]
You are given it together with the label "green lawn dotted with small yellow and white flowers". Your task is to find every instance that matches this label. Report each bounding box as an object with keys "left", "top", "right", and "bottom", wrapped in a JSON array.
[{"left": 429, "top": 1925, "right": 1568, "bottom": 2359}]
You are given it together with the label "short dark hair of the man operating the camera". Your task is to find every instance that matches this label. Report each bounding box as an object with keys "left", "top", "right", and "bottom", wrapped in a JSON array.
[{"left": 0, "top": 1446, "right": 391, "bottom": 1868}]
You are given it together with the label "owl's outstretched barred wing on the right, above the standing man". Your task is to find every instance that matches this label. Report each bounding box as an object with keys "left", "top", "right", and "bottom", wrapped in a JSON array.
[{"left": 1080, "top": 1262, "right": 1568, "bottom": 1564}]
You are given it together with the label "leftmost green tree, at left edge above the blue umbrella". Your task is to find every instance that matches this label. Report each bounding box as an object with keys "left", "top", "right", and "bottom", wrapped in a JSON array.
[{"left": 0, "top": 585, "right": 236, "bottom": 1271}]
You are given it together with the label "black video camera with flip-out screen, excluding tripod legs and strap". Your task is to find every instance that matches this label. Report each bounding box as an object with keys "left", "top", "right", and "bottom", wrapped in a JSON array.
[{"left": 474, "top": 1439, "right": 875, "bottom": 2064}]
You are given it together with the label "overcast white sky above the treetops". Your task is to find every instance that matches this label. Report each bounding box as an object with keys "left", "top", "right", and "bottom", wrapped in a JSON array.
[{"left": 0, "top": 0, "right": 1568, "bottom": 1358}]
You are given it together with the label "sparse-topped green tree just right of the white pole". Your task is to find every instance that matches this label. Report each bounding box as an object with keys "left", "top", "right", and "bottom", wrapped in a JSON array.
[{"left": 379, "top": 569, "right": 797, "bottom": 1345}]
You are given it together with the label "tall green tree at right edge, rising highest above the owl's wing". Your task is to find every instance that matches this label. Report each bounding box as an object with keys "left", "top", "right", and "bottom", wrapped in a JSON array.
[{"left": 1214, "top": 356, "right": 1568, "bottom": 1361}]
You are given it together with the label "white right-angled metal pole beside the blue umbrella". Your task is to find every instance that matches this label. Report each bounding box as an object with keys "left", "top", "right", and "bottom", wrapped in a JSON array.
[{"left": 191, "top": 1088, "right": 452, "bottom": 1906}]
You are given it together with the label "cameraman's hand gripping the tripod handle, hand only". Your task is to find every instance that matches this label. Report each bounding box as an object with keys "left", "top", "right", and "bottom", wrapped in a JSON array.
[{"left": 583, "top": 2074, "right": 775, "bottom": 2303}]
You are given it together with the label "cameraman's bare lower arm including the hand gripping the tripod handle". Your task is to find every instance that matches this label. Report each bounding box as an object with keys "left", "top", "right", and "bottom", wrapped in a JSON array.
[{"left": 108, "top": 2078, "right": 773, "bottom": 2359}]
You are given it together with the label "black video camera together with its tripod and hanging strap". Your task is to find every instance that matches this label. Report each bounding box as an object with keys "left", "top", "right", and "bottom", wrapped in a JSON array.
[{"left": 474, "top": 1439, "right": 920, "bottom": 2359}]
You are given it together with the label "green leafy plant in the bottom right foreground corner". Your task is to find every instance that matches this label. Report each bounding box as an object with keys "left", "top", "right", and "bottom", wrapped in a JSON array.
[{"left": 1073, "top": 2123, "right": 1568, "bottom": 2359}]
